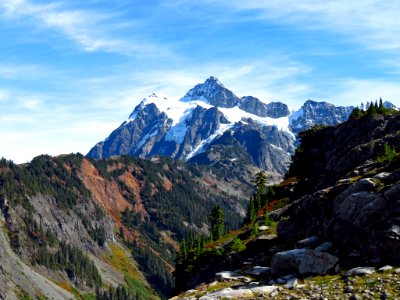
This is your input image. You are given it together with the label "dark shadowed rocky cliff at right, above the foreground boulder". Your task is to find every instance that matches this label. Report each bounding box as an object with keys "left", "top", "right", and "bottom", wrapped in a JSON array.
[{"left": 278, "top": 114, "right": 400, "bottom": 262}]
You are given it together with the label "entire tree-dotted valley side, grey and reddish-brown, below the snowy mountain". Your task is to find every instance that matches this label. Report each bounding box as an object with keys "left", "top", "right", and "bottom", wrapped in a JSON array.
[{"left": 0, "top": 154, "right": 244, "bottom": 299}]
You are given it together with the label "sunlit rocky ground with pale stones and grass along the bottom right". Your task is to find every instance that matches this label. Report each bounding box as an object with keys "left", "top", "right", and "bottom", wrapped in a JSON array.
[{"left": 172, "top": 266, "right": 400, "bottom": 300}]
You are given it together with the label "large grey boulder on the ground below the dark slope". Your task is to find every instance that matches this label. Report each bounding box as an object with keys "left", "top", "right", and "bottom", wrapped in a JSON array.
[{"left": 271, "top": 249, "right": 339, "bottom": 275}]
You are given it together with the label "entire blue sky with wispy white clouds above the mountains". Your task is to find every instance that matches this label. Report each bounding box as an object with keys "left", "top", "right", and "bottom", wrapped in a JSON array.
[{"left": 0, "top": 0, "right": 400, "bottom": 163}]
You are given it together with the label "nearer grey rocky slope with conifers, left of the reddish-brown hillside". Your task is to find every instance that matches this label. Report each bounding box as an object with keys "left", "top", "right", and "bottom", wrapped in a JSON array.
[{"left": 0, "top": 155, "right": 158, "bottom": 299}]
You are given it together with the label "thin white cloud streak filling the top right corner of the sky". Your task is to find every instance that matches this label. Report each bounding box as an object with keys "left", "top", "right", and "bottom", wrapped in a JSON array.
[{"left": 206, "top": 0, "right": 400, "bottom": 50}]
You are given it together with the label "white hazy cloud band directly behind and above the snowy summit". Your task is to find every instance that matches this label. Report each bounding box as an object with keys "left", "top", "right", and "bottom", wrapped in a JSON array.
[{"left": 104, "top": 55, "right": 312, "bottom": 106}]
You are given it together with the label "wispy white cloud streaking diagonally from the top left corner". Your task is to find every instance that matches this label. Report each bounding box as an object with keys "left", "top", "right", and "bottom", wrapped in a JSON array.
[{"left": 0, "top": 0, "right": 169, "bottom": 55}]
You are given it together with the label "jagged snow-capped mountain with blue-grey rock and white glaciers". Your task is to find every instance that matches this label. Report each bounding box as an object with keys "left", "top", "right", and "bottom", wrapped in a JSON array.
[{"left": 88, "top": 77, "right": 352, "bottom": 175}]
